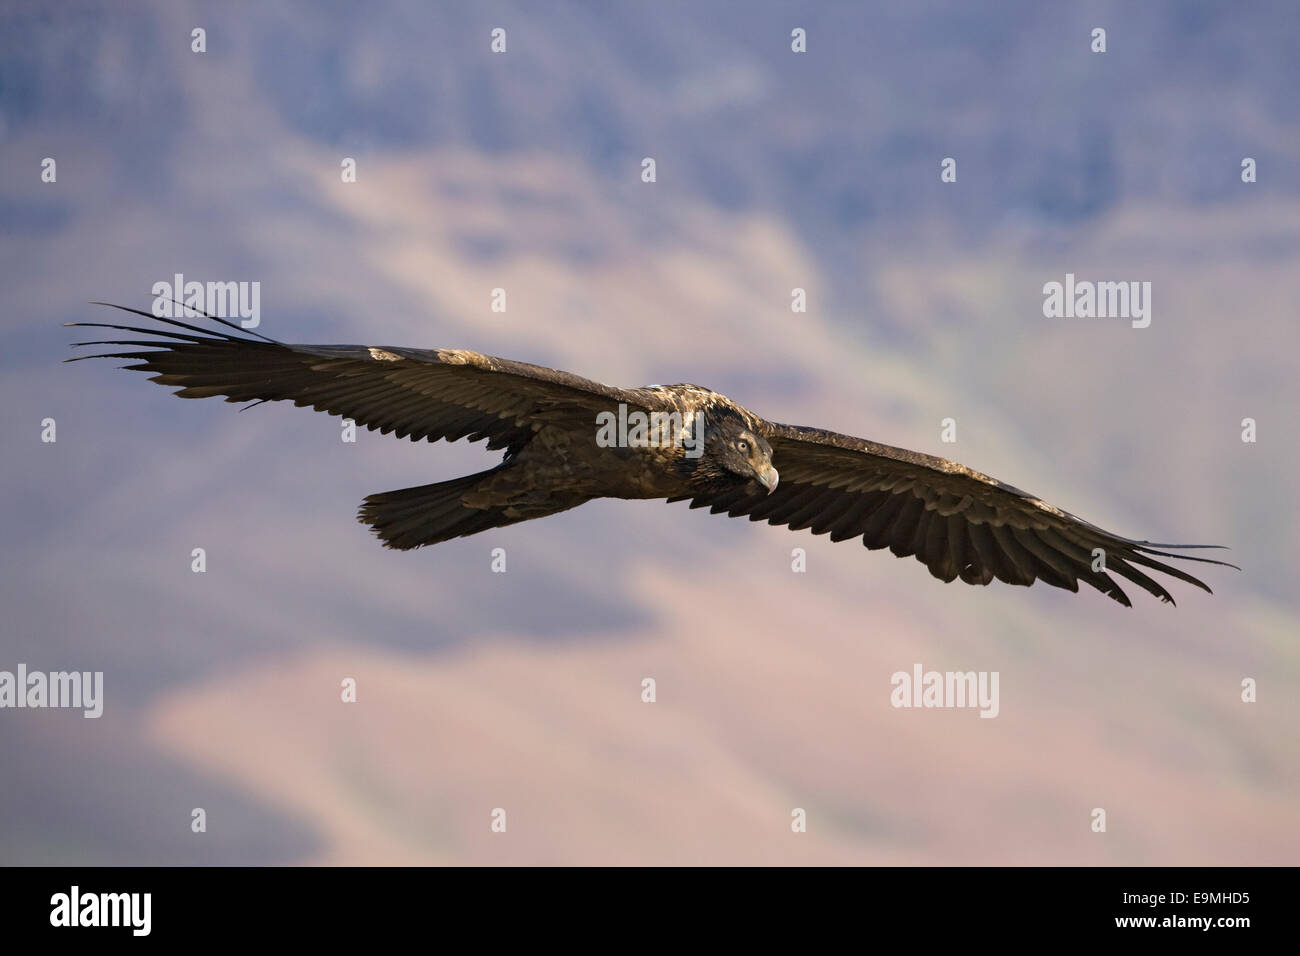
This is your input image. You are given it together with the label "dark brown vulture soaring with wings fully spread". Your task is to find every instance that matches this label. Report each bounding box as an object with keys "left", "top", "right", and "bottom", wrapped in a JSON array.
[{"left": 68, "top": 303, "right": 1235, "bottom": 606}]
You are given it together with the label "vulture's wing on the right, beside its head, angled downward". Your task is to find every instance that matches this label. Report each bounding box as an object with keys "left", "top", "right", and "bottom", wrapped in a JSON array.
[{"left": 690, "top": 421, "right": 1235, "bottom": 606}]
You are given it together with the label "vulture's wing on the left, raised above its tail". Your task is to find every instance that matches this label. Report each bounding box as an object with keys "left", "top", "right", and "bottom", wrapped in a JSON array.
[{"left": 69, "top": 303, "right": 650, "bottom": 450}]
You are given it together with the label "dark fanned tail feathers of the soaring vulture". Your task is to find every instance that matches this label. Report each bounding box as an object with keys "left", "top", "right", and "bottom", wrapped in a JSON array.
[{"left": 356, "top": 467, "right": 532, "bottom": 551}]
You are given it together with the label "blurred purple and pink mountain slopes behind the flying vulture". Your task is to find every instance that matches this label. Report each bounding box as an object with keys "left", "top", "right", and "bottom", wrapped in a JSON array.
[{"left": 0, "top": 0, "right": 1300, "bottom": 865}]
